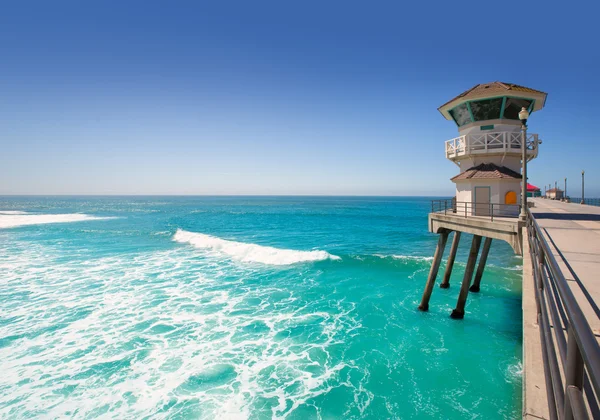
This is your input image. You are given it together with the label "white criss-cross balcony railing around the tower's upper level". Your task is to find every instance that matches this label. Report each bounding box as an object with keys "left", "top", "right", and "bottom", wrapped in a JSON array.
[{"left": 446, "top": 131, "right": 539, "bottom": 160}]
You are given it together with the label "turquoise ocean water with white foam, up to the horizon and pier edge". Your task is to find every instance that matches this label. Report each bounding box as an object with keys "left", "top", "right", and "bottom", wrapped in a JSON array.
[{"left": 0, "top": 197, "right": 522, "bottom": 419}]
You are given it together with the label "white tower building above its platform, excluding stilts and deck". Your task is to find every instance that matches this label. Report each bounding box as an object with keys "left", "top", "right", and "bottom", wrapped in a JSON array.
[{"left": 438, "top": 82, "right": 547, "bottom": 215}]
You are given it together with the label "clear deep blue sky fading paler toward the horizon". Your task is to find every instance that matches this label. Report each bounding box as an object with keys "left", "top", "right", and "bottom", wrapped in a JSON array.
[{"left": 0, "top": 0, "right": 600, "bottom": 197}]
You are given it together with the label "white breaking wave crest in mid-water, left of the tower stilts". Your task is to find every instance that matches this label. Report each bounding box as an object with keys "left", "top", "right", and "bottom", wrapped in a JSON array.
[{"left": 173, "top": 229, "right": 340, "bottom": 265}]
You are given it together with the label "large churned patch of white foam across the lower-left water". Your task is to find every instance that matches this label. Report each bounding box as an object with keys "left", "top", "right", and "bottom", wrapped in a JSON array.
[{"left": 0, "top": 241, "right": 360, "bottom": 419}]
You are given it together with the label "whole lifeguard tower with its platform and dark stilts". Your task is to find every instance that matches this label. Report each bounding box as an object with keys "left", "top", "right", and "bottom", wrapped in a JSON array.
[{"left": 419, "top": 82, "right": 547, "bottom": 318}]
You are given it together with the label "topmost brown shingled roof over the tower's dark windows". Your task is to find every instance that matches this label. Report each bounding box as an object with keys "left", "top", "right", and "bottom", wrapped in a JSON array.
[{"left": 438, "top": 81, "right": 548, "bottom": 120}]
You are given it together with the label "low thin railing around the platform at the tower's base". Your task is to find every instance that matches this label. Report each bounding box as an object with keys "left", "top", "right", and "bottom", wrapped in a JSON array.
[{"left": 431, "top": 199, "right": 521, "bottom": 221}]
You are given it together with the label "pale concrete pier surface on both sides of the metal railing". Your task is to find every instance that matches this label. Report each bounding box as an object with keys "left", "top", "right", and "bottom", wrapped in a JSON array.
[{"left": 523, "top": 198, "right": 600, "bottom": 419}]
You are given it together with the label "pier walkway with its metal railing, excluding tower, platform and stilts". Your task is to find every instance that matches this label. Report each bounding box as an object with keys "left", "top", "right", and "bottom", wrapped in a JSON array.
[{"left": 523, "top": 198, "right": 600, "bottom": 419}]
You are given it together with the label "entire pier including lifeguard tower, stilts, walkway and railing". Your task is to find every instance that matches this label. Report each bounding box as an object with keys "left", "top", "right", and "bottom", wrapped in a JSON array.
[{"left": 419, "top": 82, "right": 600, "bottom": 420}]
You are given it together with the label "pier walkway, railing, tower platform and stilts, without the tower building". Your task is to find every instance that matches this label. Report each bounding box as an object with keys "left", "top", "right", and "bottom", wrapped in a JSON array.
[{"left": 419, "top": 198, "right": 600, "bottom": 420}]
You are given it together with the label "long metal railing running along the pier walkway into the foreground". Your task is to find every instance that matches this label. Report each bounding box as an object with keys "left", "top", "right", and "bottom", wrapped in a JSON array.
[{"left": 527, "top": 210, "right": 600, "bottom": 420}]
